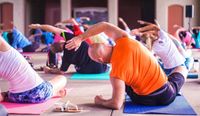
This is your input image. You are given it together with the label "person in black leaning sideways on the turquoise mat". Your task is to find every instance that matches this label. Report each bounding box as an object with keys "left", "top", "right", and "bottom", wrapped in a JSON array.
[{"left": 29, "top": 24, "right": 109, "bottom": 74}]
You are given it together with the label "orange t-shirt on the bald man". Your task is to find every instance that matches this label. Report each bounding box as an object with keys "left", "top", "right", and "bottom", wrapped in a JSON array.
[{"left": 110, "top": 37, "right": 167, "bottom": 95}]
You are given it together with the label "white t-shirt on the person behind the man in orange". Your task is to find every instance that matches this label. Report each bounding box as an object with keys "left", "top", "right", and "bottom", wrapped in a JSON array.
[{"left": 152, "top": 30, "right": 185, "bottom": 69}]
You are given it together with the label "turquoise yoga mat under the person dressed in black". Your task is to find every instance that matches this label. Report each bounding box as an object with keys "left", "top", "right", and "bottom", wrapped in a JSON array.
[{"left": 71, "top": 72, "right": 110, "bottom": 80}]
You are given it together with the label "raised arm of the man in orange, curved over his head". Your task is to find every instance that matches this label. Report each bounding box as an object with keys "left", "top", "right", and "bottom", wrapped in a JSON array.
[{"left": 65, "top": 22, "right": 128, "bottom": 50}]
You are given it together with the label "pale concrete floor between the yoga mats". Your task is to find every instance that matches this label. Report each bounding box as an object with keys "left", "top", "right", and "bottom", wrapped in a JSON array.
[{"left": 0, "top": 53, "right": 200, "bottom": 116}]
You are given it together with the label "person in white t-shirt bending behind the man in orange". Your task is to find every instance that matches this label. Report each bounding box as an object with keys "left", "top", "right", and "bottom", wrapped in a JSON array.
[{"left": 132, "top": 20, "right": 193, "bottom": 75}]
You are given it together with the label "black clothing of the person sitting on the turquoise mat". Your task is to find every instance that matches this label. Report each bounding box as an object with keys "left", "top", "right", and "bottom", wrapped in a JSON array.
[{"left": 60, "top": 32, "right": 108, "bottom": 73}]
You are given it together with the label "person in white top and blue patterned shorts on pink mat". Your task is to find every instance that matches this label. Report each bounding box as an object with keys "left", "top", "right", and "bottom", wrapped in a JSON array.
[{"left": 0, "top": 36, "right": 67, "bottom": 103}]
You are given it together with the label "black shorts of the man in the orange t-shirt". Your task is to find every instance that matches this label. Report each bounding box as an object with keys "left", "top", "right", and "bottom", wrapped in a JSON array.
[{"left": 126, "top": 72, "right": 185, "bottom": 105}]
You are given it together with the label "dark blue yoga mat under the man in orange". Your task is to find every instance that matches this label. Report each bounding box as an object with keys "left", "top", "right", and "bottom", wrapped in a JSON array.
[{"left": 124, "top": 96, "right": 196, "bottom": 115}]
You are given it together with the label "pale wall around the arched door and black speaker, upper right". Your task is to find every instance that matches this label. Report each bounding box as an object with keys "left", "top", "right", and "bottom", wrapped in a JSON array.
[{"left": 156, "top": 0, "right": 200, "bottom": 31}]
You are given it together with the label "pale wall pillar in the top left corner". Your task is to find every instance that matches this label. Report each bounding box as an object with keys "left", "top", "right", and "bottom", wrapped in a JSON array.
[{"left": 0, "top": 0, "right": 25, "bottom": 33}]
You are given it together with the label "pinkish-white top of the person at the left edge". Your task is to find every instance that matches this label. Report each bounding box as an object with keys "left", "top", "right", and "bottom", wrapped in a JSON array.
[{"left": 0, "top": 47, "right": 43, "bottom": 93}]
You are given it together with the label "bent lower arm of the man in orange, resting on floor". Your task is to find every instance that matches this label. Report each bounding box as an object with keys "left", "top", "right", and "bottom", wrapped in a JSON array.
[{"left": 95, "top": 78, "right": 125, "bottom": 110}]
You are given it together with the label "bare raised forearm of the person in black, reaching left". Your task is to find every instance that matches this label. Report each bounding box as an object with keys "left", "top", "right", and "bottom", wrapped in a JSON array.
[{"left": 29, "top": 24, "right": 66, "bottom": 34}]
